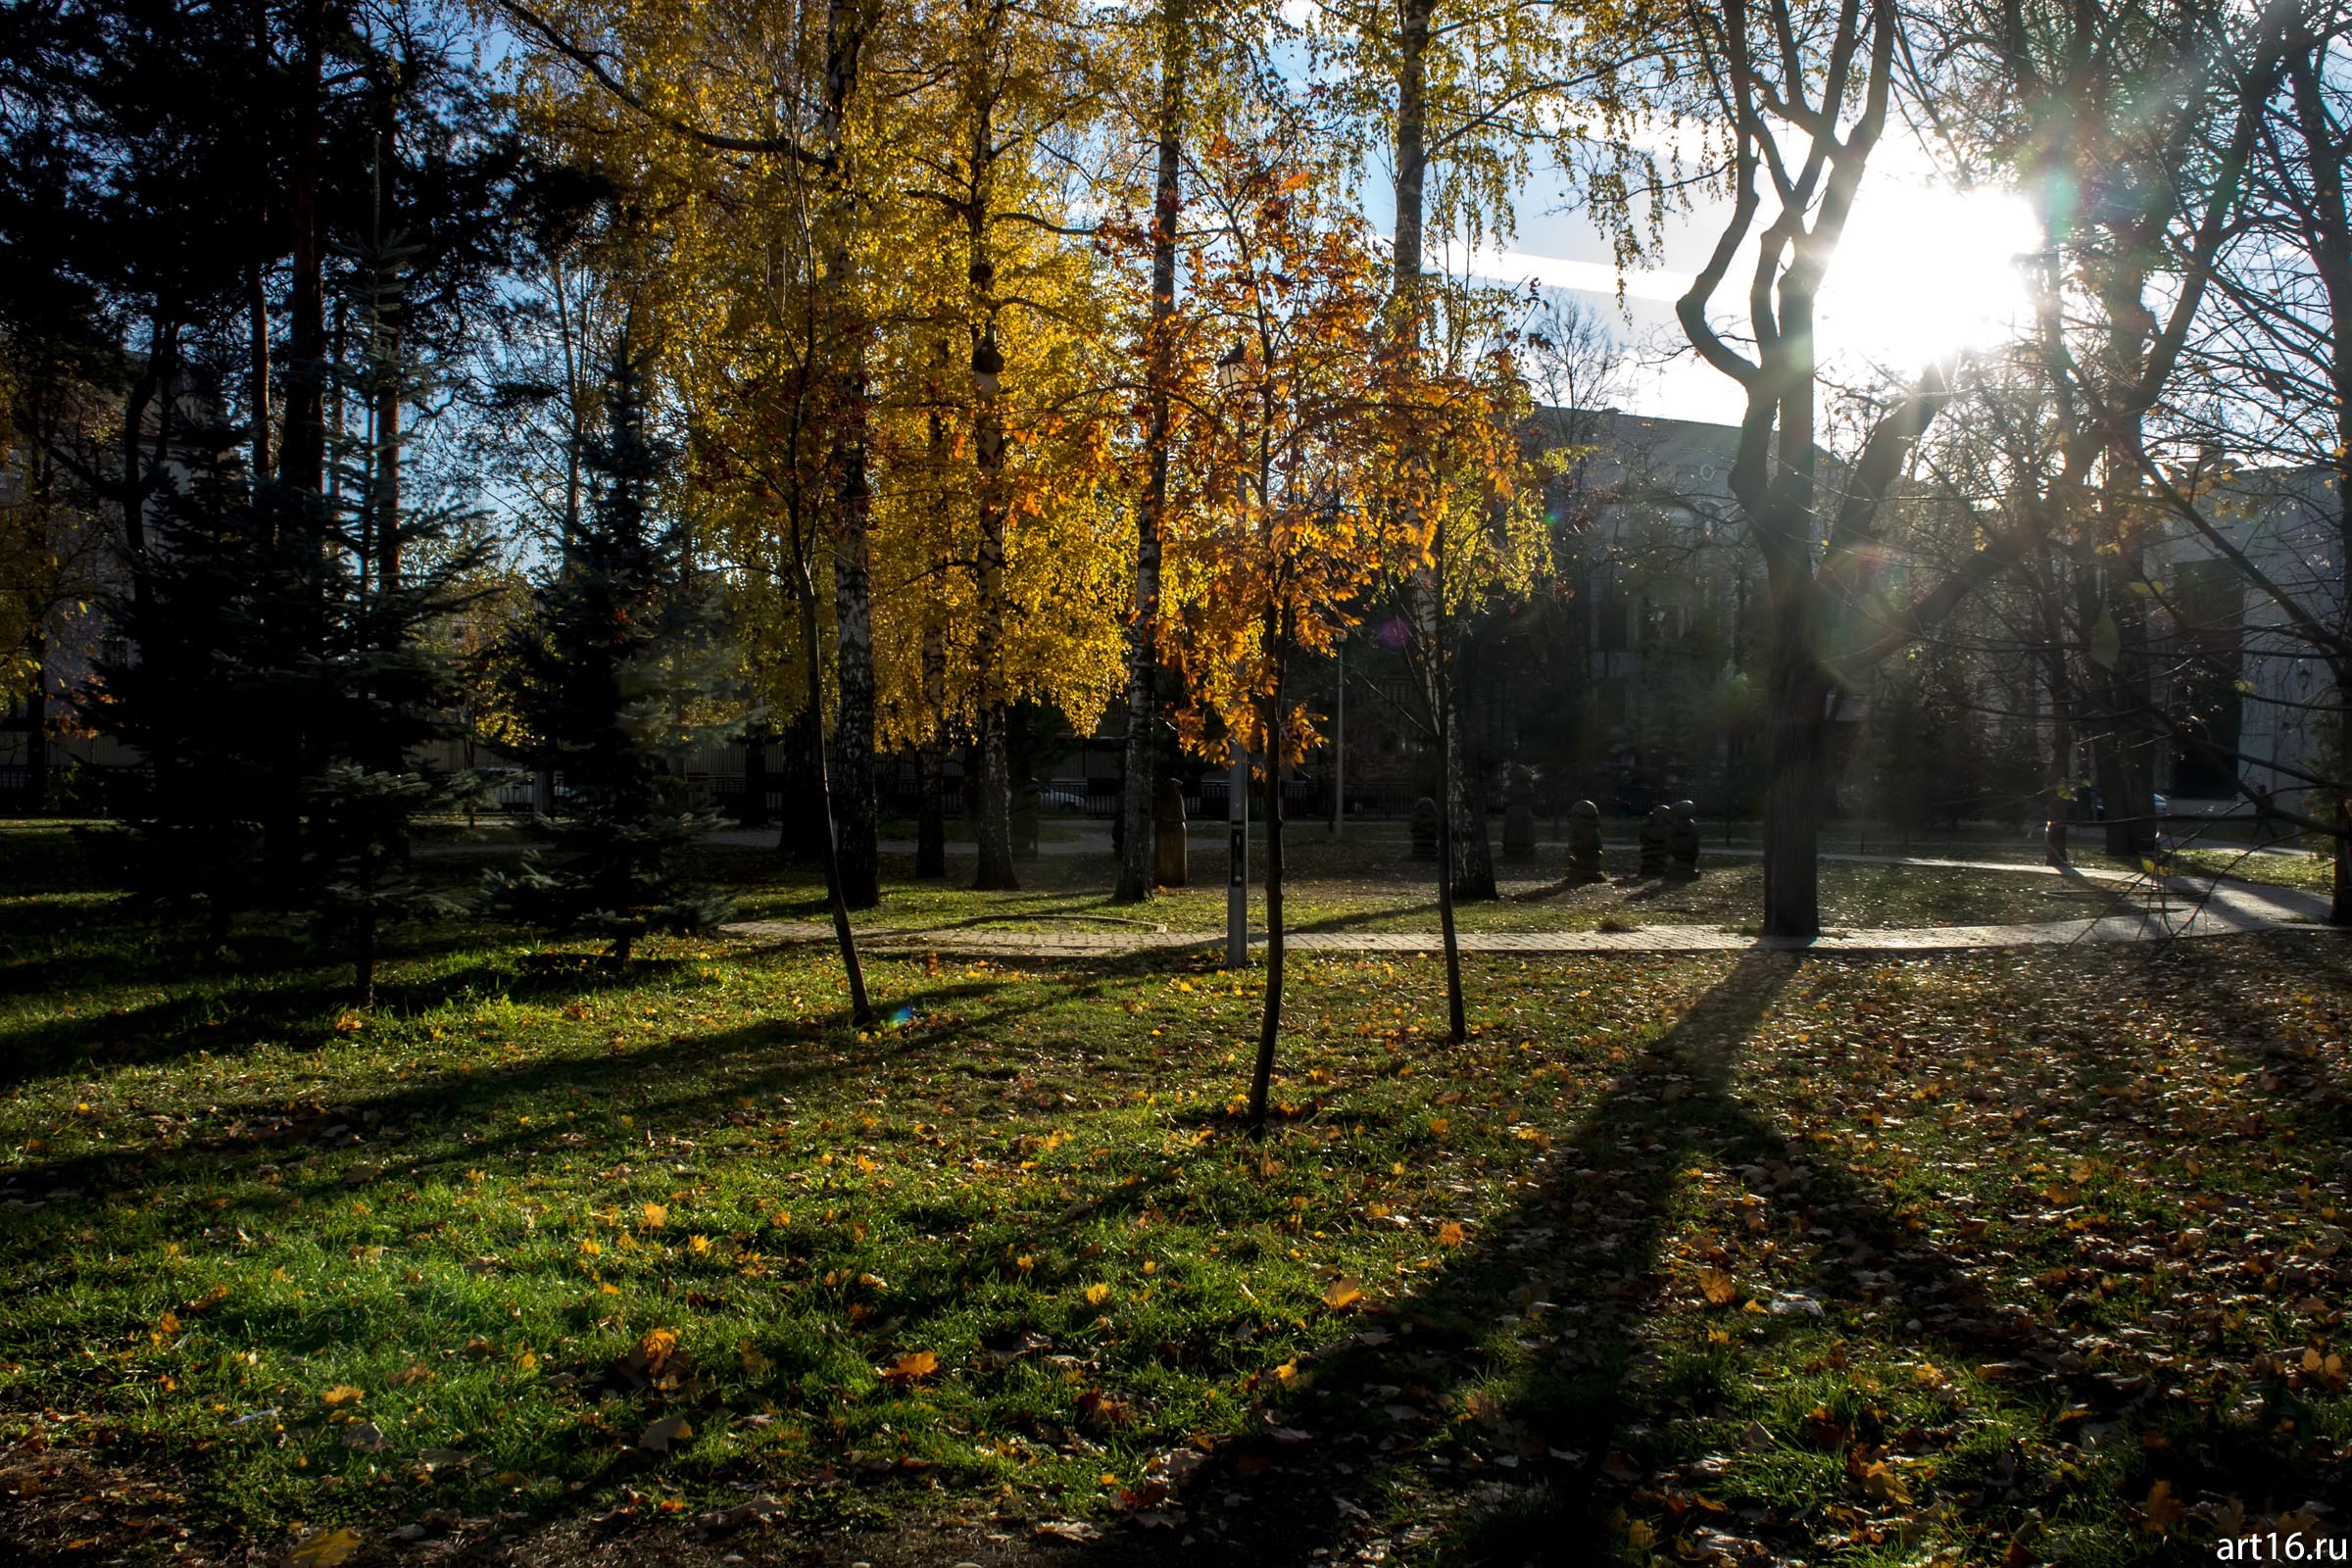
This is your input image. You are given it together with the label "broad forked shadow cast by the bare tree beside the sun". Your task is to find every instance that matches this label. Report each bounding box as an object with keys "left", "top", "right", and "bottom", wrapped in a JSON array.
[{"left": 1035, "top": 953, "right": 2079, "bottom": 1568}]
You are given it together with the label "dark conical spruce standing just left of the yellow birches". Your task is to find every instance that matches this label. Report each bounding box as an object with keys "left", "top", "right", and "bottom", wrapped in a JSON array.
[{"left": 489, "top": 331, "right": 741, "bottom": 964}]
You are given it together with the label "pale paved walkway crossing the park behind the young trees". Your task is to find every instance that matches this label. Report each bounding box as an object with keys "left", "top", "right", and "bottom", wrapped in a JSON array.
[{"left": 727, "top": 856, "right": 2328, "bottom": 959}]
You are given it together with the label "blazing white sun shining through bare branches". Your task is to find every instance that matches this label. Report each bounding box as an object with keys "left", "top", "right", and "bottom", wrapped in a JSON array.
[{"left": 1818, "top": 174, "right": 2041, "bottom": 371}]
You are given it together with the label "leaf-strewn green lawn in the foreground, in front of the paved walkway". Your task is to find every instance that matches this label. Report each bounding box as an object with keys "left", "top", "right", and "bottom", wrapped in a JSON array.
[{"left": 0, "top": 830, "right": 2352, "bottom": 1568}]
